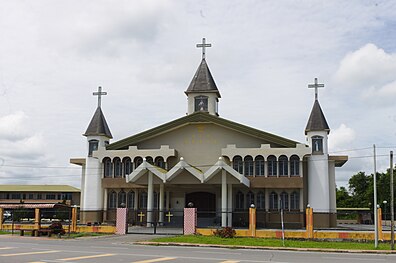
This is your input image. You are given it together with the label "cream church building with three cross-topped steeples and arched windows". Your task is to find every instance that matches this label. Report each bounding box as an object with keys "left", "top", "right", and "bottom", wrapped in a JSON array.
[{"left": 70, "top": 39, "right": 348, "bottom": 228}]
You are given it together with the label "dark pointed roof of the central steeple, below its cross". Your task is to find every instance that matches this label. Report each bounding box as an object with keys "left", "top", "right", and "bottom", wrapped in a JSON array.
[{"left": 185, "top": 58, "right": 221, "bottom": 98}]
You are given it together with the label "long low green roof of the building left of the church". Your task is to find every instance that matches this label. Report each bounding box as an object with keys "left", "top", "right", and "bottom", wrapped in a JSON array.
[{"left": 0, "top": 184, "right": 80, "bottom": 193}]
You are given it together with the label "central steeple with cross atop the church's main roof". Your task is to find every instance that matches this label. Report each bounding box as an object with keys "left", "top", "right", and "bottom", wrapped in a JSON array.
[{"left": 185, "top": 38, "right": 221, "bottom": 116}]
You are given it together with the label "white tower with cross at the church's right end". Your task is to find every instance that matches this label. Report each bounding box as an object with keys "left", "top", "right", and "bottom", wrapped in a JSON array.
[{"left": 305, "top": 78, "right": 335, "bottom": 227}]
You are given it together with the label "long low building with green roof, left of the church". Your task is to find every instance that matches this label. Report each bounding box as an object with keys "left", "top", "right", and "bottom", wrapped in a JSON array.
[{"left": 0, "top": 185, "right": 80, "bottom": 206}]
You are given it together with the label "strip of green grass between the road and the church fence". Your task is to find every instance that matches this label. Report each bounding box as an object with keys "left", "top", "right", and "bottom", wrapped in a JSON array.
[{"left": 151, "top": 235, "right": 390, "bottom": 250}]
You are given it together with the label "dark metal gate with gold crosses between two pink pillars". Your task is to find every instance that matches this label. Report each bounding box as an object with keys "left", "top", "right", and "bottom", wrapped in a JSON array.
[{"left": 127, "top": 209, "right": 184, "bottom": 235}]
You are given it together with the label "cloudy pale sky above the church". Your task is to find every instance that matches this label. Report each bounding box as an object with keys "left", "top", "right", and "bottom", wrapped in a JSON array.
[{"left": 0, "top": 0, "right": 396, "bottom": 190}]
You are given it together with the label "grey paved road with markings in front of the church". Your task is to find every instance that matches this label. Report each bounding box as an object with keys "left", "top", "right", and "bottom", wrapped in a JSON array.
[{"left": 0, "top": 235, "right": 396, "bottom": 263}]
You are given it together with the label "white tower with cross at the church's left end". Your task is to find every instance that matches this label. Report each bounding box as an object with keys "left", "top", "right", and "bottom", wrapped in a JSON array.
[{"left": 81, "top": 87, "right": 113, "bottom": 223}]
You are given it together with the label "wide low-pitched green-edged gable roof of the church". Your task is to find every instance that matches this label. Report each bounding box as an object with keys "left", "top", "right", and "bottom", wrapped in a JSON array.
[{"left": 106, "top": 112, "right": 299, "bottom": 150}]
